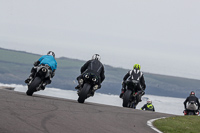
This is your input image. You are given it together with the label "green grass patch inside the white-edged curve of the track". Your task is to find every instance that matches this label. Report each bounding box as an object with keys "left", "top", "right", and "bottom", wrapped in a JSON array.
[{"left": 153, "top": 116, "right": 200, "bottom": 133}]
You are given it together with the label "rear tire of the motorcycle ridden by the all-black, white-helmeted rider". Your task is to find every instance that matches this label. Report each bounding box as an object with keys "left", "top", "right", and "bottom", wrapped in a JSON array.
[{"left": 78, "top": 83, "right": 91, "bottom": 103}]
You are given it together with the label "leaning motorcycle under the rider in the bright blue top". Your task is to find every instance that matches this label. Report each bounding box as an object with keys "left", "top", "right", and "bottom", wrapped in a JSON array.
[{"left": 26, "top": 64, "right": 52, "bottom": 96}]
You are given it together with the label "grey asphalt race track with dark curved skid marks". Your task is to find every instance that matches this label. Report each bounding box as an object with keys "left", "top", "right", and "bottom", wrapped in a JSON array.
[{"left": 0, "top": 89, "right": 172, "bottom": 133}]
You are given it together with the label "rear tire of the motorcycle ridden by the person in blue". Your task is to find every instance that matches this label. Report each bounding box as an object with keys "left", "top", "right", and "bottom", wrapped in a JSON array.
[{"left": 26, "top": 77, "right": 42, "bottom": 96}]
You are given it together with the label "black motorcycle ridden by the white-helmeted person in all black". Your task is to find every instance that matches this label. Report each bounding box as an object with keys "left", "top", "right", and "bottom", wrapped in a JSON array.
[{"left": 78, "top": 73, "right": 99, "bottom": 103}]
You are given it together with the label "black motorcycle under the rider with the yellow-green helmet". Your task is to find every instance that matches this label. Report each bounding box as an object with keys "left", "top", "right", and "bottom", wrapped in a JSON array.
[{"left": 122, "top": 80, "right": 142, "bottom": 109}]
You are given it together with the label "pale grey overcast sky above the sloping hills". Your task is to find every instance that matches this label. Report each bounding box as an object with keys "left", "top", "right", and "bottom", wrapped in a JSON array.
[{"left": 0, "top": 0, "right": 200, "bottom": 79}]
